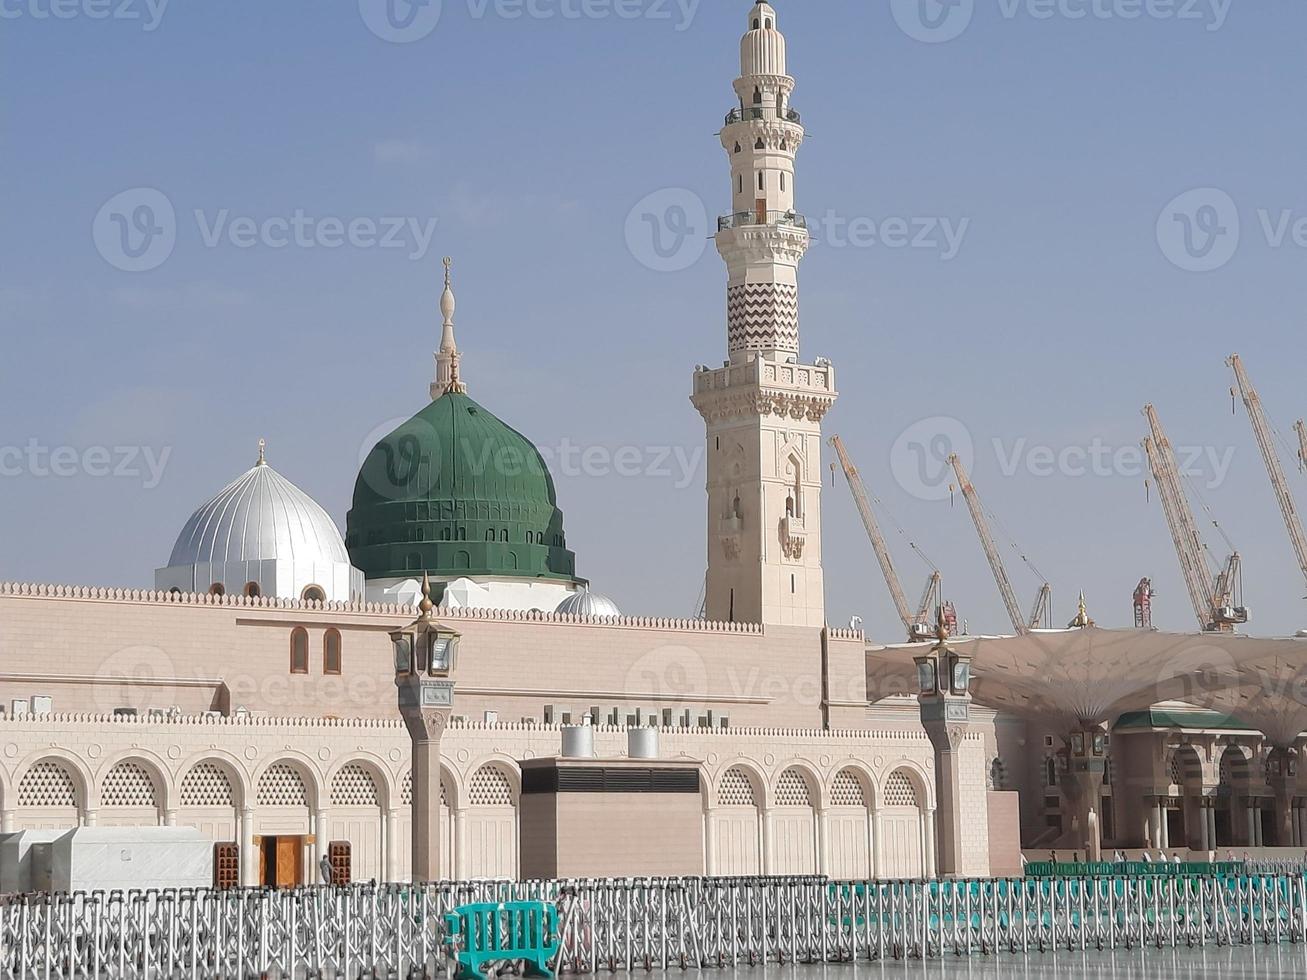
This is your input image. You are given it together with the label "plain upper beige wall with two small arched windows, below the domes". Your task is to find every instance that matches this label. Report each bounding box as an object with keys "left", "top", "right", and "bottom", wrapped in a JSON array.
[{"left": 0, "top": 587, "right": 865, "bottom": 728}]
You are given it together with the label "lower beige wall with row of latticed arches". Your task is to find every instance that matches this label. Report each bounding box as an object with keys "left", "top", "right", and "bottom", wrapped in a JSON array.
[{"left": 0, "top": 716, "right": 987, "bottom": 883}]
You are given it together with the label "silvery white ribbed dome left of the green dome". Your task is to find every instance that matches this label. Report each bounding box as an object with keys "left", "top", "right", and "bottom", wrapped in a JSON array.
[{"left": 169, "top": 460, "right": 349, "bottom": 567}]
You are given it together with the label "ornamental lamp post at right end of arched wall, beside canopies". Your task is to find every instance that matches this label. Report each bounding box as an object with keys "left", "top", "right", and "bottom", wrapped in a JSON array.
[{"left": 912, "top": 614, "right": 971, "bottom": 877}]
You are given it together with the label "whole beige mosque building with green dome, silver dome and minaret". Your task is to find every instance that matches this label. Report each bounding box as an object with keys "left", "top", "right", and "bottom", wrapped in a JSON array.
[{"left": 0, "top": 1, "right": 1291, "bottom": 885}]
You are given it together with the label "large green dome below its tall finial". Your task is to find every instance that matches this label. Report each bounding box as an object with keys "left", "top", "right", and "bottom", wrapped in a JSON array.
[{"left": 345, "top": 392, "right": 576, "bottom": 581}]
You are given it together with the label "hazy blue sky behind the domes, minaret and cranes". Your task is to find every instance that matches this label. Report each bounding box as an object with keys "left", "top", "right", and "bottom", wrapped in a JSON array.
[{"left": 0, "top": 0, "right": 1307, "bottom": 639}]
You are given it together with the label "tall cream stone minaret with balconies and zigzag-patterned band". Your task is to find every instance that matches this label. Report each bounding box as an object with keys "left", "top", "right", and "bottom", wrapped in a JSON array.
[{"left": 693, "top": 0, "right": 836, "bottom": 627}]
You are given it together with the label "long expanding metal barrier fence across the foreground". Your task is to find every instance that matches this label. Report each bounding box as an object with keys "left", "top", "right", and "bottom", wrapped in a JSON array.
[{"left": 0, "top": 875, "right": 1307, "bottom": 980}]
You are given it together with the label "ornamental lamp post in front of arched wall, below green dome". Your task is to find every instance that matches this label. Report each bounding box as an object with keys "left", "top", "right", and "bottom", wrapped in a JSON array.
[{"left": 391, "top": 575, "right": 459, "bottom": 882}]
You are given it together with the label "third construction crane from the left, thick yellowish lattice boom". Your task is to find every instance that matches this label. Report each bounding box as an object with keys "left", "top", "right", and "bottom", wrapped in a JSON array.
[{"left": 1144, "top": 405, "right": 1248, "bottom": 632}]
